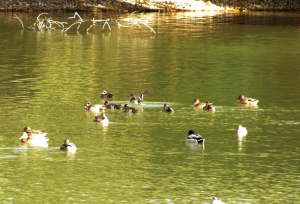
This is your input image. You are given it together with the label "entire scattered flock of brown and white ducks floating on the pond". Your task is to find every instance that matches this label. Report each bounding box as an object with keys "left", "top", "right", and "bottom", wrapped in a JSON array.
[{"left": 19, "top": 91, "right": 258, "bottom": 204}]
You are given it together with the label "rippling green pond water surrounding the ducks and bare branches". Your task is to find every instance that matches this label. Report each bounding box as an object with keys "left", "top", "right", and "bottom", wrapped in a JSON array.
[{"left": 0, "top": 12, "right": 300, "bottom": 204}]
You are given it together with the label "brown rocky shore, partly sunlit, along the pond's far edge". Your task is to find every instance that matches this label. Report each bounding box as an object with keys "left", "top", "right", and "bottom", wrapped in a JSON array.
[{"left": 0, "top": 0, "right": 300, "bottom": 12}]
